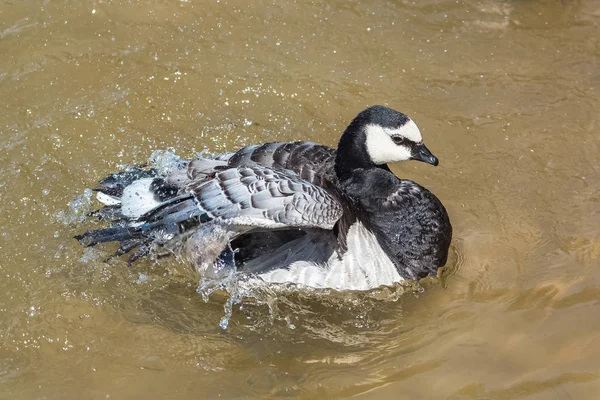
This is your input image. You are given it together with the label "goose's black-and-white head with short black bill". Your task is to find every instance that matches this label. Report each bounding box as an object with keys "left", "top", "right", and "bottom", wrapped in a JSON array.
[{"left": 336, "top": 106, "right": 439, "bottom": 175}]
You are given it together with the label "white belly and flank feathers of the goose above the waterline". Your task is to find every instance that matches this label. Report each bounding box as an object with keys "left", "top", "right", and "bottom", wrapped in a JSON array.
[{"left": 259, "top": 222, "right": 403, "bottom": 290}]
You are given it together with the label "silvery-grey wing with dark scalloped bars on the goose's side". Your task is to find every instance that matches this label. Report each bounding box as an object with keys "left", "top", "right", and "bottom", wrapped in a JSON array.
[{"left": 184, "top": 166, "right": 342, "bottom": 229}]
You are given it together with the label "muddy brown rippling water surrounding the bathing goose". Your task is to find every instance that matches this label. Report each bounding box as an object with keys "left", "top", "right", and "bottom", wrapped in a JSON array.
[{"left": 0, "top": 0, "right": 600, "bottom": 399}]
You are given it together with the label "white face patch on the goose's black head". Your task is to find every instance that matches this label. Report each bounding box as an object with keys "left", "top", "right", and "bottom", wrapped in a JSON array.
[{"left": 365, "top": 120, "right": 423, "bottom": 165}]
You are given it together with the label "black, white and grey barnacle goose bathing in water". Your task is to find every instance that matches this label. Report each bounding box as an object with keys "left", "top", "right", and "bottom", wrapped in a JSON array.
[{"left": 76, "top": 106, "right": 452, "bottom": 291}]
